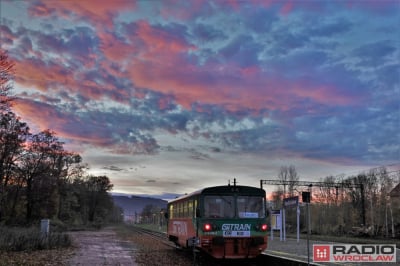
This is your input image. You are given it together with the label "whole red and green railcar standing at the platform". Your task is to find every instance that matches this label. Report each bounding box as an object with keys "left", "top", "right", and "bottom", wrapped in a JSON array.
[{"left": 166, "top": 182, "right": 267, "bottom": 259}]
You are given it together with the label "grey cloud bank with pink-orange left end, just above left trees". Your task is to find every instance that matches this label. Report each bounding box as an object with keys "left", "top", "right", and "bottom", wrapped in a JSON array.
[{"left": 14, "top": 98, "right": 158, "bottom": 154}]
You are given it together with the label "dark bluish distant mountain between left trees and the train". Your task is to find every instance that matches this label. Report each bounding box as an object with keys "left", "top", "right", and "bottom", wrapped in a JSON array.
[{"left": 112, "top": 195, "right": 167, "bottom": 221}]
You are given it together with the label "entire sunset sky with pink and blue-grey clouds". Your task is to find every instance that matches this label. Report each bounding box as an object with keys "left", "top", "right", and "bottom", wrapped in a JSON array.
[{"left": 0, "top": 0, "right": 400, "bottom": 198}]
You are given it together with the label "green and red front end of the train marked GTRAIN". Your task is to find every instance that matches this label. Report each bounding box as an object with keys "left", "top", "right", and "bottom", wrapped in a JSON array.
[{"left": 197, "top": 186, "right": 267, "bottom": 259}]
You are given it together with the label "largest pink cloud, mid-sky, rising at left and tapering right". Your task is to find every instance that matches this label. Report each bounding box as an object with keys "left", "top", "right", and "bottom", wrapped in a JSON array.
[{"left": 115, "top": 21, "right": 360, "bottom": 111}]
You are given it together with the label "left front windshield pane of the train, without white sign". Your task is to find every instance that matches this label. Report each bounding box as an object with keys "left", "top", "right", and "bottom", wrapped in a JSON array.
[{"left": 204, "top": 196, "right": 235, "bottom": 218}]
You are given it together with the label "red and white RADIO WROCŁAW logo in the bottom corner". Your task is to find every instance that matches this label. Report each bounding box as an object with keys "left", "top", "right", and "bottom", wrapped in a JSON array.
[{"left": 313, "top": 244, "right": 396, "bottom": 262}]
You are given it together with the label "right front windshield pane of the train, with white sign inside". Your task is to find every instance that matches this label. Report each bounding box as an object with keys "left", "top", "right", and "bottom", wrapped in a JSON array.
[{"left": 237, "top": 196, "right": 265, "bottom": 218}]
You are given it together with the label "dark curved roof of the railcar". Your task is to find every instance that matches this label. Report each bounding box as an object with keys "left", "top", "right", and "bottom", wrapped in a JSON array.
[{"left": 168, "top": 185, "right": 265, "bottom": 203}]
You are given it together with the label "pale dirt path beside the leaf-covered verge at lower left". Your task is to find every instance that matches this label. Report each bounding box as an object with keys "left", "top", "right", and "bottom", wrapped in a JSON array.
[{"left": 67, "top": 228, "right": 137, "bottom": 266}]
